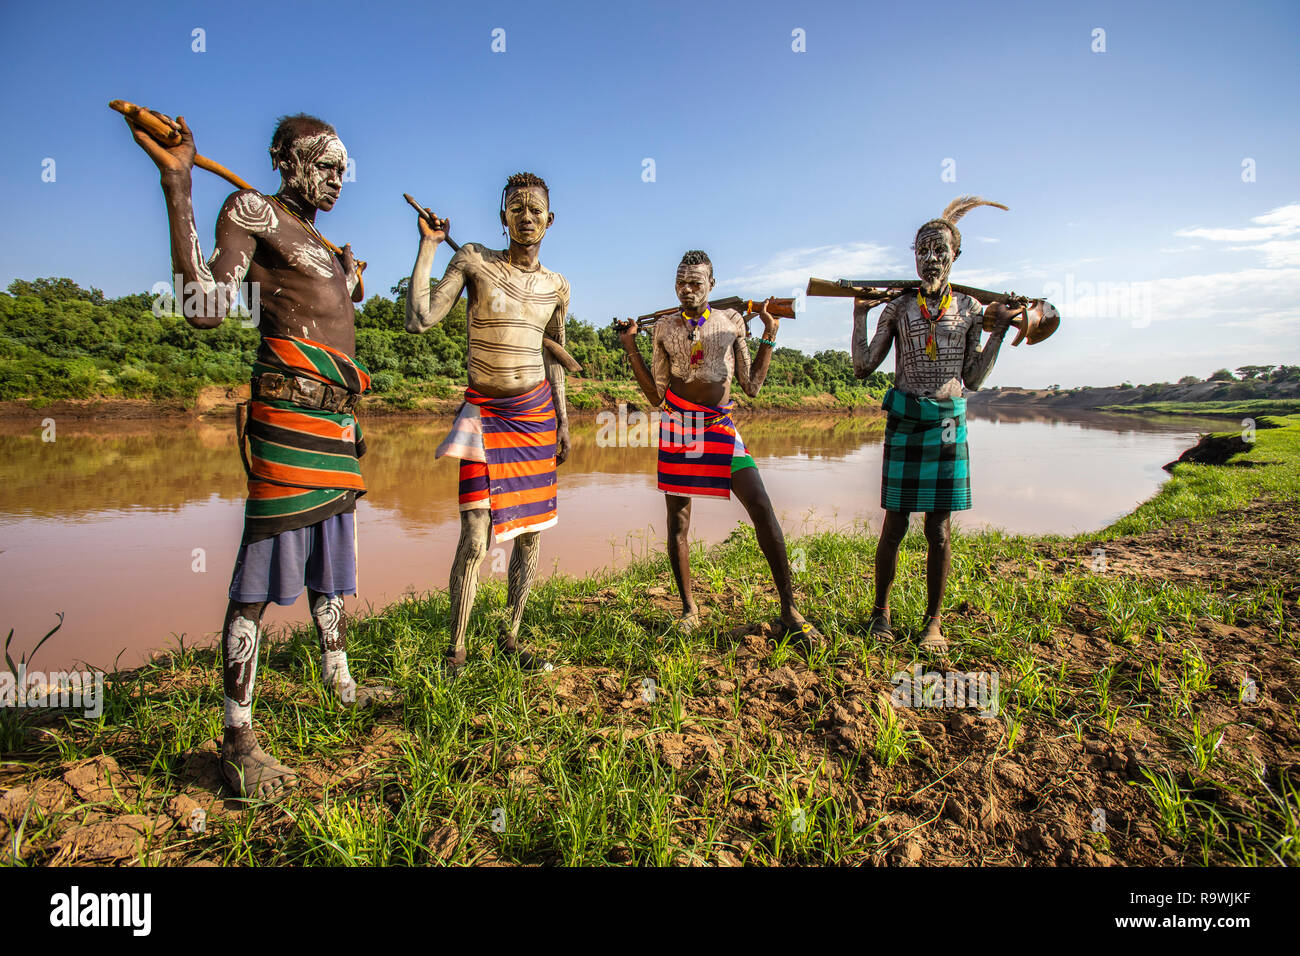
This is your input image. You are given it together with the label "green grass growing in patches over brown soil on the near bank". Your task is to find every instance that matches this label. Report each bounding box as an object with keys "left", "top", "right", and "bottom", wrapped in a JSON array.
[{"left": 0, "top": 416, "right": 1300, "bottom": 866}]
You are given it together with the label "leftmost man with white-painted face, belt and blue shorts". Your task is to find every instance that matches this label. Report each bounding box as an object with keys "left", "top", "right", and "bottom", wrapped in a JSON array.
[{"left": 131, "top": 114, "right": 387, "bottom": 797}]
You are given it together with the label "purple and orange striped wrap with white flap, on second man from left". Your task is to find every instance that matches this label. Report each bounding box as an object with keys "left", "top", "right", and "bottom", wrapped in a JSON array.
[{"left": 437, "top": 381, "right": 558, "bottom": 542}]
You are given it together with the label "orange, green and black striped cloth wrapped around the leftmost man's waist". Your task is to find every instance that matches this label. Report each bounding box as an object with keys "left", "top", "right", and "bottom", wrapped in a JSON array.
[{"left": 244, "top": 336, "right": 371, "bottom": 544}]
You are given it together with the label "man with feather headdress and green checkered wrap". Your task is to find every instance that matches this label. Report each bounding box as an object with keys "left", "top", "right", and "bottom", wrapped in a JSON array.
[{"left": 853, "top": 196, "right": 1015, "bottom": 654}]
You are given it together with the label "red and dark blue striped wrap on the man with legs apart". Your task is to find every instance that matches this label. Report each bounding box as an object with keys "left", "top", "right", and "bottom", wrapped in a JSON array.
[{"left": 659, "top": 389, "right": 754, "bottom": 498}]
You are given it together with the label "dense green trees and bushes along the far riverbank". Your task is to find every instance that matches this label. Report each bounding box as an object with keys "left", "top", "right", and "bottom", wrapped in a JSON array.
[{"left": 0, "top": 278, "right": 893, "bottom": 401}]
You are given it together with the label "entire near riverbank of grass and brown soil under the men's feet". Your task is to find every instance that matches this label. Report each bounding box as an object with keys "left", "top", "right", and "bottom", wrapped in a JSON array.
[{"left": 0, "top": 416, "right": 1300, "bottom": 865}]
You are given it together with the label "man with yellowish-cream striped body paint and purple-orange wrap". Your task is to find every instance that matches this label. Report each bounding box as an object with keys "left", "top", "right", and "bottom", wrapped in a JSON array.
[{"left": 406, "top": 173, "right": 569, "bottom": 676}]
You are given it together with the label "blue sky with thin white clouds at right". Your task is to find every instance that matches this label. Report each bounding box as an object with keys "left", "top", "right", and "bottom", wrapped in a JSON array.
[{"left": 0, "top": 0, "right": 1300, "bottom": 386}]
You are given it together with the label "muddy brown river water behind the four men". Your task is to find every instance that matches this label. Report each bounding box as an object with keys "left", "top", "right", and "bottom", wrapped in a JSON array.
[{"left": 0, "top": 411, "right": 1232, "bottom": 669}]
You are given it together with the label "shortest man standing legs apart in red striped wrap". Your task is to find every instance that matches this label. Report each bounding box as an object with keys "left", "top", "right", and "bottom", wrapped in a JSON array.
[{"left": 616, "top": 250, "right": 822, "bottom": 643}]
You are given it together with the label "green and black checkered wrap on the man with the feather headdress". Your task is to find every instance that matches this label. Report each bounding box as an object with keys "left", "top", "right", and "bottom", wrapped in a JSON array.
[{"left": 880, "top": 389, "right": 971, "bottom": 511}]
